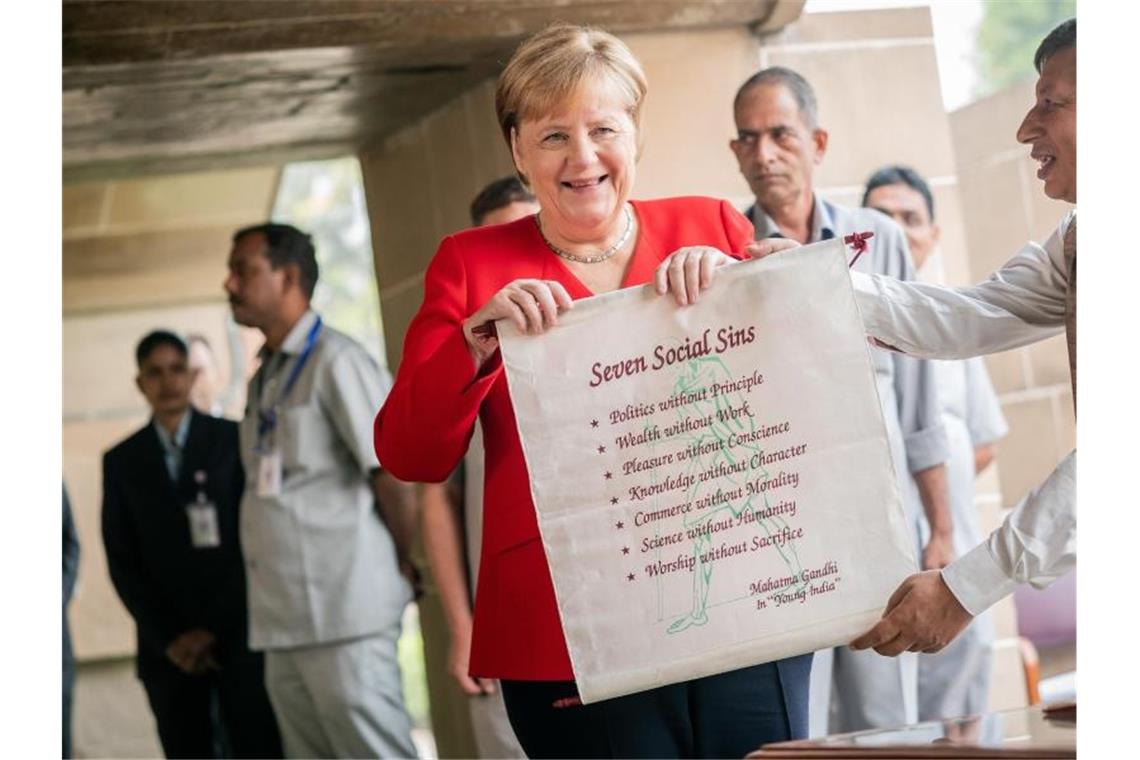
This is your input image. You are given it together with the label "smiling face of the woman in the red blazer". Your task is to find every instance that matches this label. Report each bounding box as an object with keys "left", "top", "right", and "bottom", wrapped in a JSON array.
[{"left": 511, "top": 80, "right": 637, "bottom": 243}]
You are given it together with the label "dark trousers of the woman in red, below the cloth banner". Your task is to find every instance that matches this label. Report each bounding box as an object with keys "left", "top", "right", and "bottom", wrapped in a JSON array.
[{"left": 503, "top": 654, "right": 812, "bottom": 758}]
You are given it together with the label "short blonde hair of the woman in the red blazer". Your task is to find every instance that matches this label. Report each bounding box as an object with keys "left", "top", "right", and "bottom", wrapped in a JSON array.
[{"left": 495, "top": 24, "right": 649, "bottom": 148}]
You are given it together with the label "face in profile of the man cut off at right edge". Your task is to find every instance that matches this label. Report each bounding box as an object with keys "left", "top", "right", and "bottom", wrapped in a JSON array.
[{"left": 1017, "top": 48, "right": 1076, "bottom": 203}]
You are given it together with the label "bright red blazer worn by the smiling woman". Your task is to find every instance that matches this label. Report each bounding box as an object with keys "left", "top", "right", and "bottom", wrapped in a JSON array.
[{"left": 375, "top": 197, "right": 752, "bottom": 680}]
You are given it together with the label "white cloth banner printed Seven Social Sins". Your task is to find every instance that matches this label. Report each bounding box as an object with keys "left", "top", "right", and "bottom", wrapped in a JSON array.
[{"left": 498, "top": 239, "right": 915, "bottom": 703}]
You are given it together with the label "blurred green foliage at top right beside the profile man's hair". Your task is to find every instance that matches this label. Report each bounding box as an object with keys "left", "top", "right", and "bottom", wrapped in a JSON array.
[{"left": 975, "top": 0, "right": 1076, "bottom": 98}]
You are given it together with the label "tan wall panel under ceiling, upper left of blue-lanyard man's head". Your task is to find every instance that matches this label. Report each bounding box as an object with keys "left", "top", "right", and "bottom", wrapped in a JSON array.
[{"left": 107, "top": 167, "right": 279, "bottom": 229}]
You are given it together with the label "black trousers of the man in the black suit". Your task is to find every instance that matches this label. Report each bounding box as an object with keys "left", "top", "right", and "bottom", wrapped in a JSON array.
[{"left": 143, "top": 652, "right": 284, "bottom": 758}]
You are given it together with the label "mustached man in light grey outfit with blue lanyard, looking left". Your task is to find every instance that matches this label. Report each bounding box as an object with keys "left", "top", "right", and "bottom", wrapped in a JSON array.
[{"left": 225, "top": 223, "right": 415, "bottom": 758}]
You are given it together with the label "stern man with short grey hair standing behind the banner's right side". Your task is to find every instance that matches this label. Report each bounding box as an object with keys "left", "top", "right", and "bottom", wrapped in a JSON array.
[{"left": 730, "top": 66, "right": 953, "bottom": 734}]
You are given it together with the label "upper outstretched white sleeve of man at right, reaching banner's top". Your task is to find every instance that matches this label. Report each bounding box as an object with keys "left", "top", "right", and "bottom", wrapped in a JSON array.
[{"left": 852, "top": 214, "right": 1072, "bottom": 359}]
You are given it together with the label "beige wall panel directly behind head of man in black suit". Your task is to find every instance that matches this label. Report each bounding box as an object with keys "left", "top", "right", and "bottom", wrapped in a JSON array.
[{"left": 63, "top": 304, "right": 237, "bottom": 416}]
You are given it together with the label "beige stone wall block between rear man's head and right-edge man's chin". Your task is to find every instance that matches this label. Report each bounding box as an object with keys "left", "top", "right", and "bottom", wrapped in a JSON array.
[{"left": 958, "top": 162, "right": 1029, "bottom": 281}]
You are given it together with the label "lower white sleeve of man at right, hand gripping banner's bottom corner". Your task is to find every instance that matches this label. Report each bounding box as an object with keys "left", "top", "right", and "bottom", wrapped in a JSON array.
[{"left": 942, "top": 451, "right": 1076, "bottom": 615}]
